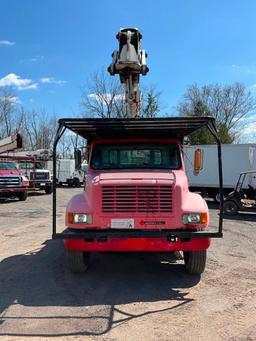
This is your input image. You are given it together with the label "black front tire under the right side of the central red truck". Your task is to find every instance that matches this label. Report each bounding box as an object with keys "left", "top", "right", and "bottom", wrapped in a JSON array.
[{"left": 183, "top": 250, "right": 207, "bottom": 275}]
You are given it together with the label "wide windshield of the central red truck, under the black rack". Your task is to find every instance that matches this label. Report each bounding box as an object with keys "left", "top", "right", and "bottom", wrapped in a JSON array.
[{"left": 91, "top": 142, "right": 181, "bottom": 169}]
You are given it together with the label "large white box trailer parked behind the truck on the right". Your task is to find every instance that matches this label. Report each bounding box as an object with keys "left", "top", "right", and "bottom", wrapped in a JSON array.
[{"left": 184, "top": 144, "right": 256, "bottom": 202}]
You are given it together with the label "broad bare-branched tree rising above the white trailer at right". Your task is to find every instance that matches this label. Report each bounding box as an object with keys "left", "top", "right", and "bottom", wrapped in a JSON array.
[{"left": 177, "top": 83, "right": 256, "bottom": 140}]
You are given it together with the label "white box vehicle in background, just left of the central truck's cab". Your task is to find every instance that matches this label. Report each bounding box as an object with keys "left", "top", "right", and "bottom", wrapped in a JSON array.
[{"left": 47, "top": 159, "right": 87, "bottom": 187}]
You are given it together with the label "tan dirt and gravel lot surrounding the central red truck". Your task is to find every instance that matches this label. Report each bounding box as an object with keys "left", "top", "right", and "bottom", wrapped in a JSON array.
[{"left": 0, "top": 188, "right": 256, "bottom": 341}]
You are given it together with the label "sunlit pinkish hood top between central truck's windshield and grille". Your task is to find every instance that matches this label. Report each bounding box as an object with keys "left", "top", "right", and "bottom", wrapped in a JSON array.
[{"left": 94, "top": 170, "right": 175, "bottom": 184}]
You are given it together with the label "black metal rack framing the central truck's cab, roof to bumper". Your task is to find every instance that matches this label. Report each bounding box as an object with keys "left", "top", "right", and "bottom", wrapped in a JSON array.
[{"left": 52, "top": 117, "right": 223, "bottom": 240}]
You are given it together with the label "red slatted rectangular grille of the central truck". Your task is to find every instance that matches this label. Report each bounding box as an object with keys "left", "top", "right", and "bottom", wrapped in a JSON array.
[{"left": 102, "top": 185, "right": 173, "bottom": 213}]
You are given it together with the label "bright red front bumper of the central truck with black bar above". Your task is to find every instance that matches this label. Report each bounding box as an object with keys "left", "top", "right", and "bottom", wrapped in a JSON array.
[{"left": 56, "top": 229, "right": 222, "bottom": 252}]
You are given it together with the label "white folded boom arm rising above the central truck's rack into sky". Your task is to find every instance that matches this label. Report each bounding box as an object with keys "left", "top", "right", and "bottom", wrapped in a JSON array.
[{"left": 108, "top": 28, "right": 149, "bottom": 118}]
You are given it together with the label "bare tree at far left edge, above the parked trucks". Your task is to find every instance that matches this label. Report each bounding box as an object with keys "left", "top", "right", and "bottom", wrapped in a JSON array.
[{"left": 0, "top": 87, "right": 23, "bottom": 138}]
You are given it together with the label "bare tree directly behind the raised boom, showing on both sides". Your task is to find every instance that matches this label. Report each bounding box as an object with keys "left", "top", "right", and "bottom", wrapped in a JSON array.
[{"left": 81, "top": 70, "right": 160, "bottom": 118}]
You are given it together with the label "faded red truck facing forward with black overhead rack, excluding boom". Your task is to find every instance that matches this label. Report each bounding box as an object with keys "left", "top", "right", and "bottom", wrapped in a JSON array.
[{"left": 53, "top": 117, "right": 223, "bottom": 274}]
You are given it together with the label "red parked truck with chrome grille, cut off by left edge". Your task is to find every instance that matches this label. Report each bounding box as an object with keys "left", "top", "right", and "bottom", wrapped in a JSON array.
[{"left": 0, "top": 158, "right": 29, "bottom": 201}]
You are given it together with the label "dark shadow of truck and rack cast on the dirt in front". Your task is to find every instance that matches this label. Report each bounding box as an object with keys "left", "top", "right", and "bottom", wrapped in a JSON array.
[{"left": 0, "top": 241, "right": 200, "bottom": 337}]
